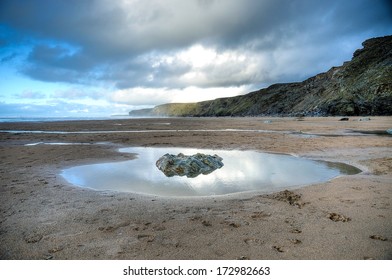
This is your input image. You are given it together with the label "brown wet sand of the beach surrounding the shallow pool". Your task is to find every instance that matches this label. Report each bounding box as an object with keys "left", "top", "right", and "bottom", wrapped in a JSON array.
[{"left": 0, "top": 117, "right": 392, "bottom": 259}]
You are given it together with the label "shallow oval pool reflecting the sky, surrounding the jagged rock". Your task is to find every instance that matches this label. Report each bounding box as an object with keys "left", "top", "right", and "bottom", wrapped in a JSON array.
[{"left": 61, "top": 147, "right": 361, "bottom": 196}]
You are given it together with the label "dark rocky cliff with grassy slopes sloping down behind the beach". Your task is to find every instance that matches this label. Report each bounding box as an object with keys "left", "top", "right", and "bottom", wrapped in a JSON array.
[{"left": 129, "top": 36, "right": 392, "bottom": 117}]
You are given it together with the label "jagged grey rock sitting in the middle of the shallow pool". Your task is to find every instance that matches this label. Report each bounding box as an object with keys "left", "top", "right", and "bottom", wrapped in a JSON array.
[{"left": 156, "top": 153, "right": 223, "bottom": 178}]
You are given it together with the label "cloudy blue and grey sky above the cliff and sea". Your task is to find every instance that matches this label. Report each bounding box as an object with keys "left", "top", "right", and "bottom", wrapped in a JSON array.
[{"left": 0, "top": 0, "right": 392, "bottom": 117}]
